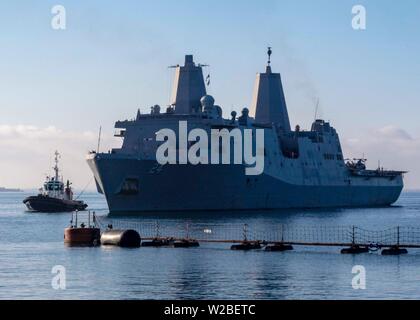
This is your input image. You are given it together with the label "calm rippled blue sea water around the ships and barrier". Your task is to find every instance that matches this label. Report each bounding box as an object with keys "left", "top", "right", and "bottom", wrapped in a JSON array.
[{"left": 0, "top": 192, "right": 420, "bottom": 299}]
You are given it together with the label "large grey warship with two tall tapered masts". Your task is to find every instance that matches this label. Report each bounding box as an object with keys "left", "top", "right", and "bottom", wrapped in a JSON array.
[{"left": 87, "top": 49, "right": 405, "bottom": 214}]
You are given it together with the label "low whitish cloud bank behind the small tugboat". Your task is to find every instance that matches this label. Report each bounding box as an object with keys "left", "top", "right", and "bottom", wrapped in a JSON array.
[{"left": 0, "top": 125, "right": 118, "bottom": 189}]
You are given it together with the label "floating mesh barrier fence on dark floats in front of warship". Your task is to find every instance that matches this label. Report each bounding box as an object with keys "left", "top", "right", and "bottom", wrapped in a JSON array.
[{"left": 96, "top": 217, "right": 420, "bottom": 255}]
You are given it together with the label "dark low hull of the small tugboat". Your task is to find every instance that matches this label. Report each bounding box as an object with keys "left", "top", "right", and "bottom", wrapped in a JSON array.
[{"left": 23, "top": 196, "right": 87, "bottom": 212}]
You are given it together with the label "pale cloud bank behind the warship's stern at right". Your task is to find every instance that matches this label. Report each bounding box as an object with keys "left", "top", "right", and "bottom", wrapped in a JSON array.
[{"left": 342, "top": 125, "right": 420, "bottom": 189}]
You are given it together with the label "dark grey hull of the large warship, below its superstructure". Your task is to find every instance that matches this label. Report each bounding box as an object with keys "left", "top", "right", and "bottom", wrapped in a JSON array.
[{"left": 88, "top": 155, "right": 403, "bottom": 214}]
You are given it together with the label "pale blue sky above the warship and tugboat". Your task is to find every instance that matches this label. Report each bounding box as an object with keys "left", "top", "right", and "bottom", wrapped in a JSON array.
[{"left": 0, "top": 0, "right": 420, "bottom": 188}]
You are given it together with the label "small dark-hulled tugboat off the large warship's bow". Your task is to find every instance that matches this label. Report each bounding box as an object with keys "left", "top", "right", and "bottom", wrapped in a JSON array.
[{"left": 23, "top": 151, "right": 87, "bottom": 212}]
